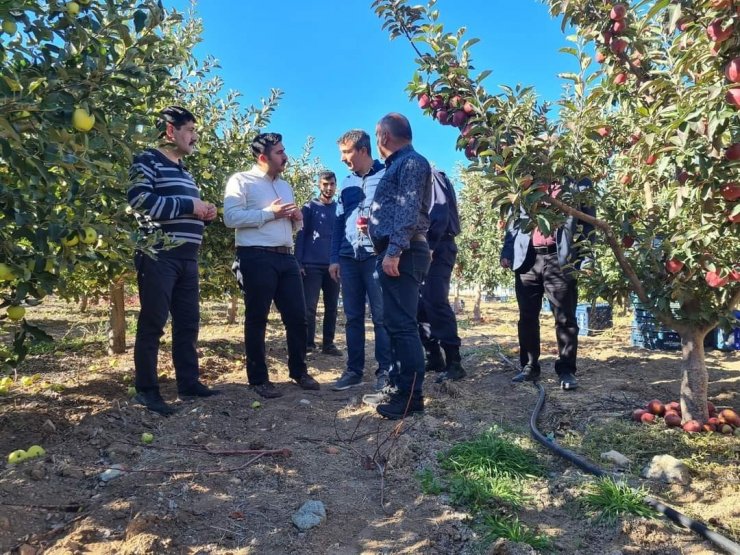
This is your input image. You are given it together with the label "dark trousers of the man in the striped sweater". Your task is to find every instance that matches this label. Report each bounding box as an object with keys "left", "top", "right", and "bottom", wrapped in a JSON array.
[{"left": 134, "top": 253, "right": 200, "bottom": 391}]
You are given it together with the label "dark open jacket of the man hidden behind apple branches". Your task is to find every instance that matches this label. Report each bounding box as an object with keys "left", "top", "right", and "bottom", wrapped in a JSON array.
[{"left": 501, "top": 177, "right": 595, "bottom": 271}]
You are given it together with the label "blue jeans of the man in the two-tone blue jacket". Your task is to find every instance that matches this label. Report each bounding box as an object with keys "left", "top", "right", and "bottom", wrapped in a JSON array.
[{"left": 339, "top": 256, "right": 391, "bottom": 376}]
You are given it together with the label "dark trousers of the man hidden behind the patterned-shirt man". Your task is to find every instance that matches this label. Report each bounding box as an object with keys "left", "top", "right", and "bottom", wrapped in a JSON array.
[{"left": 418, "top": 241, "right": 460, "bottom": 349}]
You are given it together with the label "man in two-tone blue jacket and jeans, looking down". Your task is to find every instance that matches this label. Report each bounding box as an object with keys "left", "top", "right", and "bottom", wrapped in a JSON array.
[{"left": 329, "top": 129, "right": 391, "bottom": 391}]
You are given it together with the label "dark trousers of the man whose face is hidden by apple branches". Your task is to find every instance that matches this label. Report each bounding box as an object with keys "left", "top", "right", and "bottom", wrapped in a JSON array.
[{"left": 515, "top": 251, "right": 578, "bottom": 374}]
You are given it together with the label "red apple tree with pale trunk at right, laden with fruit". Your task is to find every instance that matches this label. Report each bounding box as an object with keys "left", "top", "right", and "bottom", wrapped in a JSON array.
[{"left": 373, "top": 0, "right": 740, "bottom": 421}]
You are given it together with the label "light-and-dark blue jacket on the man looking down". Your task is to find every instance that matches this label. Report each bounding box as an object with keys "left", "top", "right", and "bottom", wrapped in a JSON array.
[{"left": 329, "top": 160, "right": 385, "bottom": 264}]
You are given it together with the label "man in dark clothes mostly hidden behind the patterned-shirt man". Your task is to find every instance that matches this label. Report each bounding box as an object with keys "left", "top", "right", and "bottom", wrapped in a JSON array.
[{"left": 418, "top": 168, "right": 465, "bottom": 383}]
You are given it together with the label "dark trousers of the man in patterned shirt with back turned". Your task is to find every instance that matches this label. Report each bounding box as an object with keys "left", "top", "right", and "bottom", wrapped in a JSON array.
[{"left": 377, "top": 241, "right": 430, "bottom": 396}]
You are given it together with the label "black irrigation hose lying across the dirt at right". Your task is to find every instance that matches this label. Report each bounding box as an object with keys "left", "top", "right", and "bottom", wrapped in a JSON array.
[{"left": 529, "top": 383, "right": 740, "bottom": 555}]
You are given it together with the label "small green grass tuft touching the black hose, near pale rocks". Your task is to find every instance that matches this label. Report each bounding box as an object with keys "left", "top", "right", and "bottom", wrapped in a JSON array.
[{"left": 583, "top": 477, "right": 658, "bottom": 522}]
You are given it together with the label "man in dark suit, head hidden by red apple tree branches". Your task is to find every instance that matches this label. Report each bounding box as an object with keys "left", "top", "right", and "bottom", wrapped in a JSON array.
[{"left": 500, "top": 178, "right": 594, "bottom": 390}]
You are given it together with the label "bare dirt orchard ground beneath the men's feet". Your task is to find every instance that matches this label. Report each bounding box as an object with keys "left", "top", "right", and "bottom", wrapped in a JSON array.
[{"left": 0, "top": 300, "right": 740, "bottom": 555}]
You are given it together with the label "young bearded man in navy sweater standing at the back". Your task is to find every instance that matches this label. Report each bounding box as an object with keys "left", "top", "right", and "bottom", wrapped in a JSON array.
[{"left": 295, "top": 171, "right": 342, "bottom": 356}]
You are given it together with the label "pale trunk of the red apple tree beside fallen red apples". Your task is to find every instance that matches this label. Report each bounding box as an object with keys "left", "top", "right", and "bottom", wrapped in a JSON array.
[{"left": 681, "top": 328, "right": 709, "bottom": 424}]
